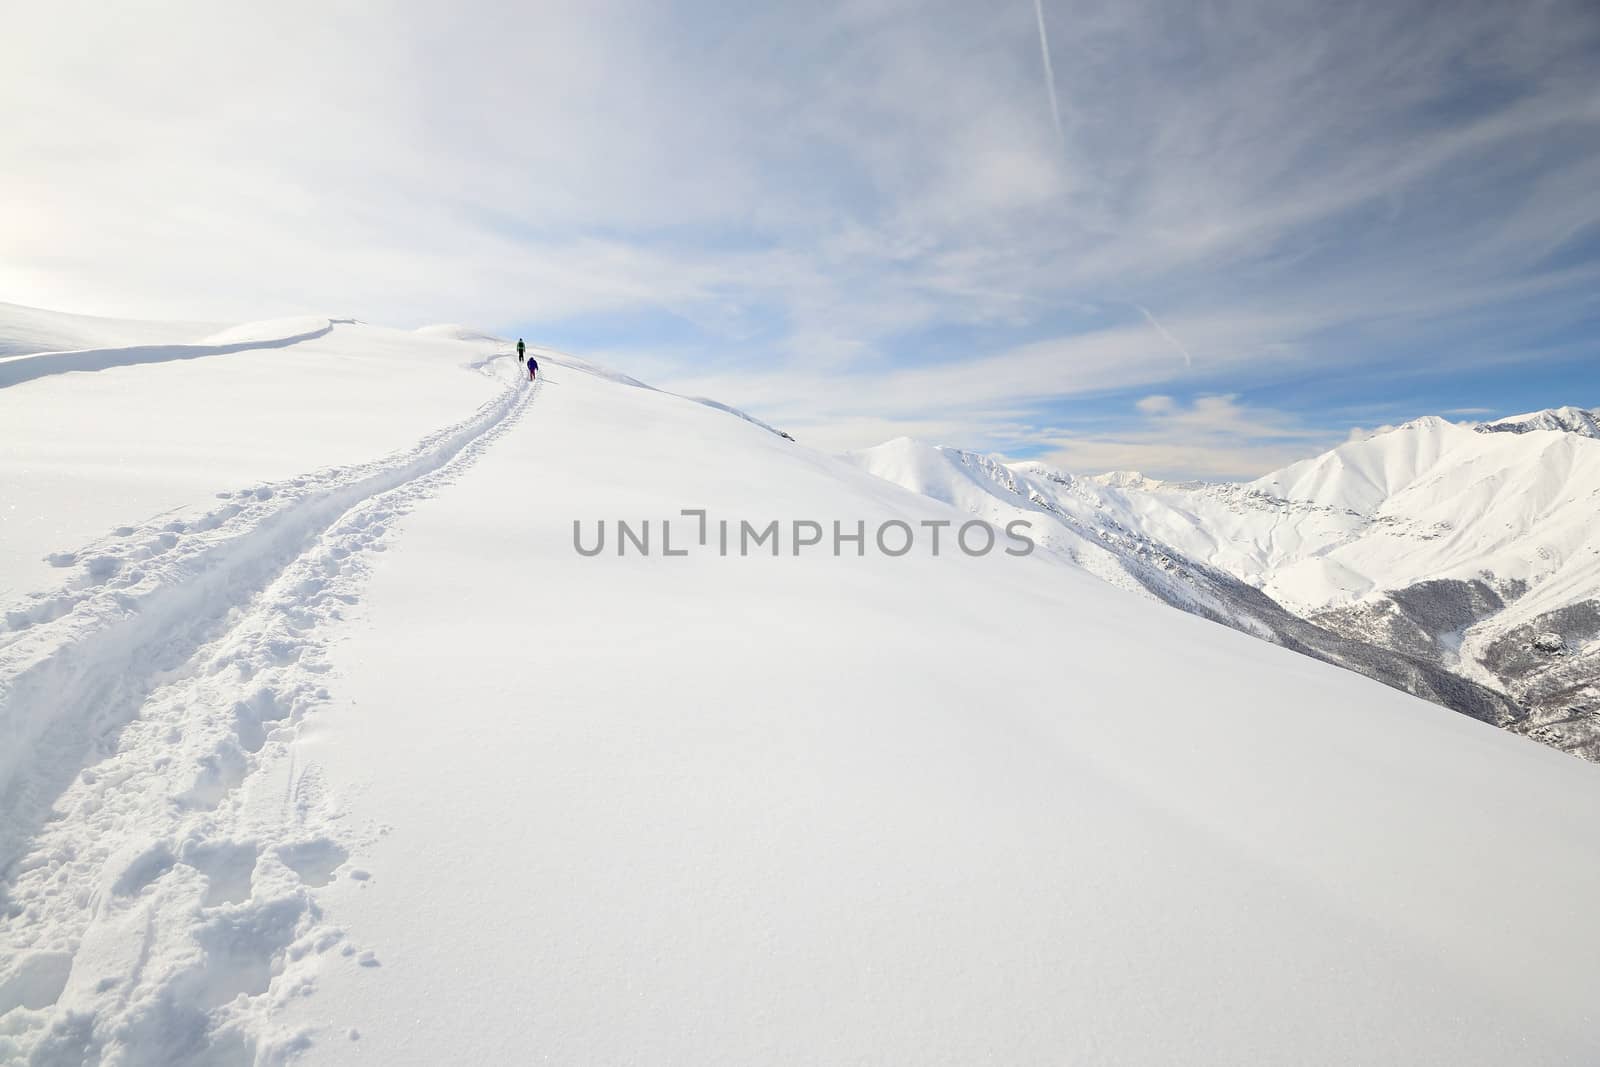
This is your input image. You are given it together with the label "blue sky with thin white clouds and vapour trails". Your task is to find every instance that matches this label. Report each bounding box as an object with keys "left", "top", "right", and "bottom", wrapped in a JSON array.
[{"left": 9, "top": 0, "right": 1600, "bottom": 477}]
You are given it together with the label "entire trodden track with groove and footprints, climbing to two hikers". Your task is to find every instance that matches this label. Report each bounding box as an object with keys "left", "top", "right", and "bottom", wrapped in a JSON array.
[{"left": 0, "top": 360, "right": 542, "bottom": 1064}]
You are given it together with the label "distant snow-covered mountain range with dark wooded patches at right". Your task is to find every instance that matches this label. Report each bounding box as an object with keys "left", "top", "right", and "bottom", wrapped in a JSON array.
[{"left": 858, "top": 408, "right": 1600, "bottom": 758}]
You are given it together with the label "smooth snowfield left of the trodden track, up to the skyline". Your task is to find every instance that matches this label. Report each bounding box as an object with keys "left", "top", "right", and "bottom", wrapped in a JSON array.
[{"left": 0, "top": 309, "right": 507, "bottom": 601}]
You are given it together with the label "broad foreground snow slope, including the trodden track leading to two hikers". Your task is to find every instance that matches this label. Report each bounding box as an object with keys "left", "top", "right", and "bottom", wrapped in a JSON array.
[{"left": 0, "top": 321, "right": 1600, "bottom": 1064}]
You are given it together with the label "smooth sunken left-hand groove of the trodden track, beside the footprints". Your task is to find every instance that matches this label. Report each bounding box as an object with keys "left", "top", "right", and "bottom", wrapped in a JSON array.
[{"left": 0, "top": 371, "right": 534, "bottom": 885}]
